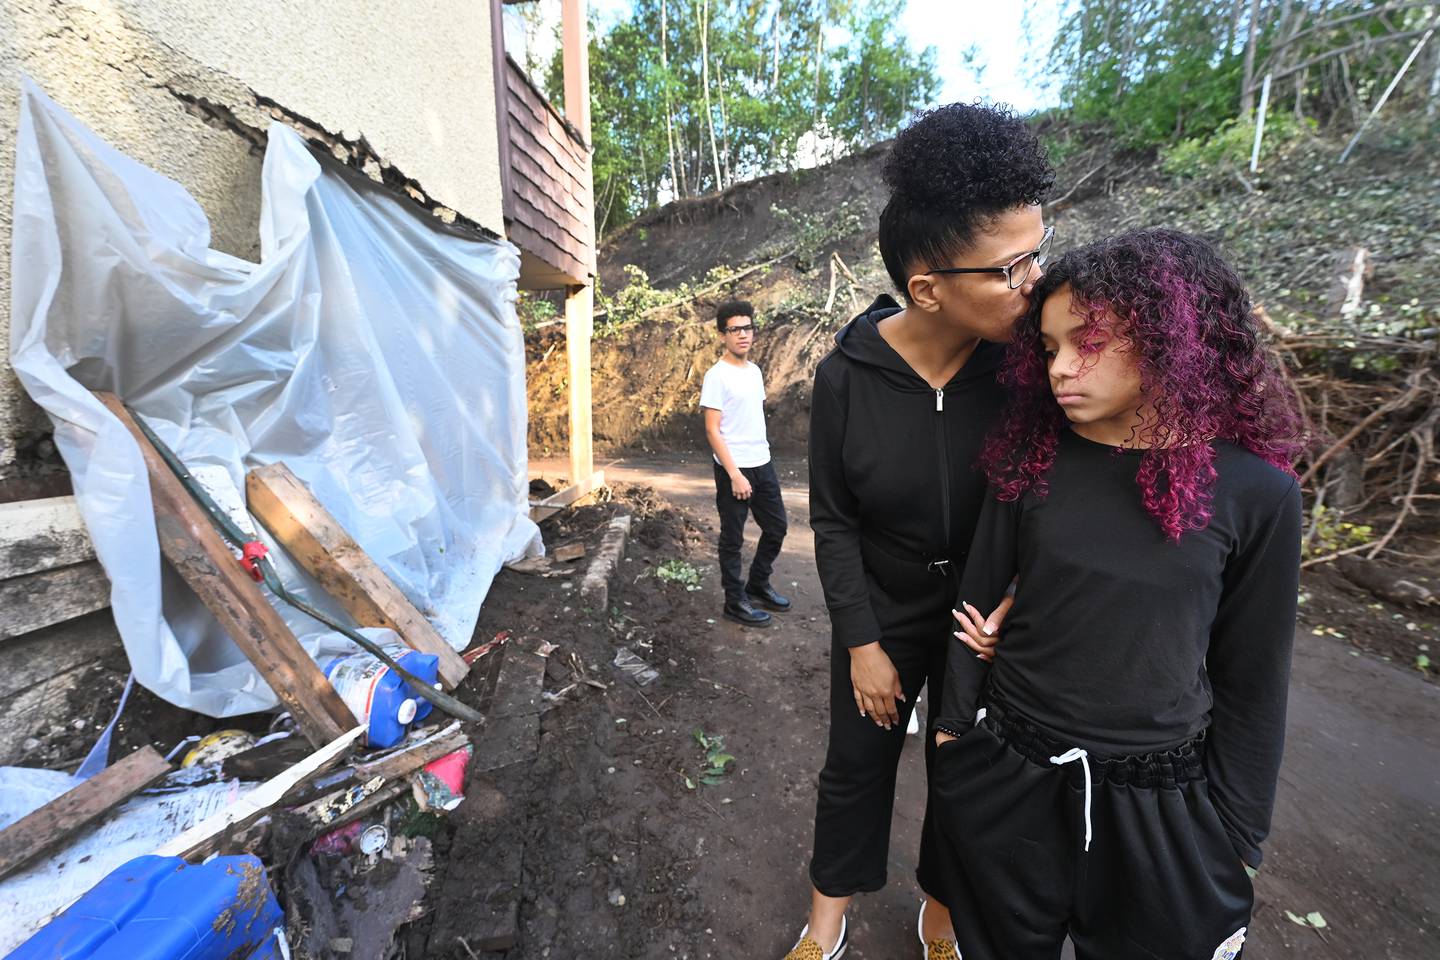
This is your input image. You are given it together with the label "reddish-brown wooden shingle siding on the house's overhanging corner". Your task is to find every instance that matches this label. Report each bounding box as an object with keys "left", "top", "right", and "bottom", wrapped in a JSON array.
[{"left": 504, "top": 58, "right": 595, "bottom": 284}]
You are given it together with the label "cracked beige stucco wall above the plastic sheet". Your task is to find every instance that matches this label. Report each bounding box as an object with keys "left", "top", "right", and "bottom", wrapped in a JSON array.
[{"left": 0, "top": 0, "right": 504, "bottom": 481}]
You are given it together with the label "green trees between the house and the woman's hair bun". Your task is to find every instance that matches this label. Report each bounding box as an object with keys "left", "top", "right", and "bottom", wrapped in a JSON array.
[{"left": 546, "top": 0, "right": 939, "bottom": 233}]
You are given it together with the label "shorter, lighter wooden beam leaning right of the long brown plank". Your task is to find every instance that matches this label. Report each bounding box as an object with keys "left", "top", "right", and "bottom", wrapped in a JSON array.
[{"left": 245, "top": 463, "right": 469, "bottom": 689}]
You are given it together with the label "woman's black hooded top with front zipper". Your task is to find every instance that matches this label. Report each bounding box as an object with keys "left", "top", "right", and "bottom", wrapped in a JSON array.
[{"left": 809, "top": 296, "right": 1004, "bottom": 646}]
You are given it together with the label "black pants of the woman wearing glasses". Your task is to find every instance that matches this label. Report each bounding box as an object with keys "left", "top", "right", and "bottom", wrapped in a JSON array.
[{"left": 811, "top": 555, "right": 956, "bottom": 902}]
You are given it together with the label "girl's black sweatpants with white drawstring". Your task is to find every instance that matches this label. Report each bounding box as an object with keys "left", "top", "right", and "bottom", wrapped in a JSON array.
[{"left": 930, "top": 702, "right": 1253, "bottom": 960}]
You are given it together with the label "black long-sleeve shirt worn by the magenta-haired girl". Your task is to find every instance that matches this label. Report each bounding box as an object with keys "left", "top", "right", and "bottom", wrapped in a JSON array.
[{"left": 936, "top": 430, "right": 1300, "bottom": 866}]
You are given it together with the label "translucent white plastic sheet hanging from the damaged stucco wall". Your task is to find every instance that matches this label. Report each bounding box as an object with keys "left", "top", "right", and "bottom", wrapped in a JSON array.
[{"left": 10, "top": 81, "right": 540, "bottom": 717}]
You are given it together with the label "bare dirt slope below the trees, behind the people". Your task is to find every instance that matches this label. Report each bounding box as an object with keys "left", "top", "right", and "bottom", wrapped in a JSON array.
[{"left": 527, "top": 123, "right": 1440, "bottom": 456}]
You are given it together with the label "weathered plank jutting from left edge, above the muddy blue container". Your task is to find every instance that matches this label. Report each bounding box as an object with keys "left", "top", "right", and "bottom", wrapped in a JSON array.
[{"left": 0, "top": 746, "right": 170, "bottom": 878}]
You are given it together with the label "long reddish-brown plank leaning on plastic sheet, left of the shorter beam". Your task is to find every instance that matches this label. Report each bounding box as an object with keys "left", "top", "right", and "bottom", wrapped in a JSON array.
[{"left": 95, "top": 393, "right": 356, "bottom": 747}]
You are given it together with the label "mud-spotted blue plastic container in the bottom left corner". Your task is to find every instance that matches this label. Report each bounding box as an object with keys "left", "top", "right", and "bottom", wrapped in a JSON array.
[{"left": 6, "top": 856, "right": 285, "bottom": 960}]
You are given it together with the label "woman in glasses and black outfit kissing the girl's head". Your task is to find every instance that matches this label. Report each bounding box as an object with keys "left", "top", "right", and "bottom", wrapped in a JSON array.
[{"left": 789, "top": 104, "right": 1054, "bottom": 960}]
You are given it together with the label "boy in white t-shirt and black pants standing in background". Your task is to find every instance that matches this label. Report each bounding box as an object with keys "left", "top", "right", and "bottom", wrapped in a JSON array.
[{"left": 700, "top": 299, "right": 791, "bottom": 626}]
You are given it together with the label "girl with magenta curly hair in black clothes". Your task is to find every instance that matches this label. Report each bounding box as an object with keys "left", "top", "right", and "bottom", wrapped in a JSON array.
[{"left": 930, "top": 230, "right": 1300, "bottom": 960}]
